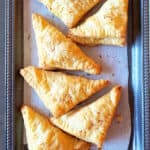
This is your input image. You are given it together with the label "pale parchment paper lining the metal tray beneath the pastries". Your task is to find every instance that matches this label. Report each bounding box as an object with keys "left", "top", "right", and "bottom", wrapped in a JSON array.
[{"left": 24, "top": 0, "right": 131, "bottom": 150}]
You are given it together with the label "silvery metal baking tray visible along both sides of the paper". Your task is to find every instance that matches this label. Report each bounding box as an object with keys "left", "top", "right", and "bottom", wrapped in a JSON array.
[{"left": 0, "top": 0, "right": 150, "bottom": 150}]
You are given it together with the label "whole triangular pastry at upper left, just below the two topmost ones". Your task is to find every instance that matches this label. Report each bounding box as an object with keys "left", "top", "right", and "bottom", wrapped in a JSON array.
[{"left": 32, "top": 14, "right": 101, "bottom": 74}]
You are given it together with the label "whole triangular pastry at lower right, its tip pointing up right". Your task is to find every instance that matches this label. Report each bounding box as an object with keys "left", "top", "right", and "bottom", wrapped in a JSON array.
[{"left": 51, "top": 86, "right": 121, "bottom": 147}]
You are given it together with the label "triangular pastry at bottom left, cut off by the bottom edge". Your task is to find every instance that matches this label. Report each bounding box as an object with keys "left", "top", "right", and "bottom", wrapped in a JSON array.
[{"left": 21, "top": 106, "right": 90, "bottom": 150}]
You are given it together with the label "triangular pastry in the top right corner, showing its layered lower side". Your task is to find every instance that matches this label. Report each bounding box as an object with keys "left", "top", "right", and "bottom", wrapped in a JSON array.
[{"left": 69, "top": 0, "right": 128, "bottom": 46}]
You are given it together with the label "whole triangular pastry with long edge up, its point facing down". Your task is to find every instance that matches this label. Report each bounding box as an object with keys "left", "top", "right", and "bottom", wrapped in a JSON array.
[{"left": 20, "top": 66, "right": 109, "bottom": 117}]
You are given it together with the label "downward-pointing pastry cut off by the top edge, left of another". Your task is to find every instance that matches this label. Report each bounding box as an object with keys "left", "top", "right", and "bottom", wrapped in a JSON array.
[{"left": 39, "top": 0, "right": 101, "bottom": 28}]
